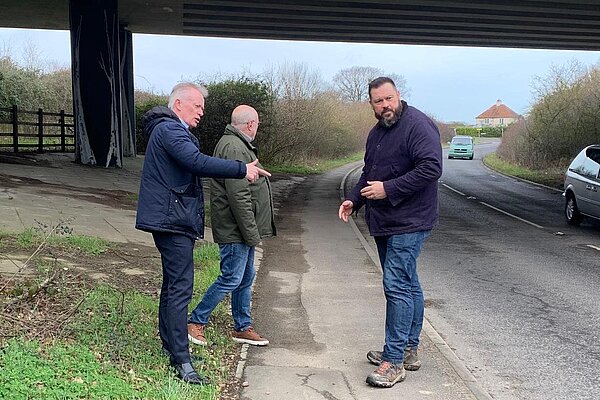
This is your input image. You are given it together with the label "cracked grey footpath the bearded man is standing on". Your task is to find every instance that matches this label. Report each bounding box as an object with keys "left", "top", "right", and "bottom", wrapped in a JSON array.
[{"left": 241, "top": 166, "right": 474, "bottom": 400}]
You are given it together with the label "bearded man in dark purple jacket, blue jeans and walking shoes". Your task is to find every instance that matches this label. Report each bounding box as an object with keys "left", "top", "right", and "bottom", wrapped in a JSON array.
[{"left": 338, "top": 77, "right": 442, "bottom": 387}]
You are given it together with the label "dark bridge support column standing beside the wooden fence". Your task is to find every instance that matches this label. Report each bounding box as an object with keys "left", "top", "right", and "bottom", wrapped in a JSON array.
[{"left": 69, "top": 0, "right": 135, "bottom": 167}]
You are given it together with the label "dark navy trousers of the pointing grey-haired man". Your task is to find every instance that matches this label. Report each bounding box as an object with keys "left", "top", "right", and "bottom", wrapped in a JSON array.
[{"left": 152, "top": 232, "right": 194, "bottom": 364}]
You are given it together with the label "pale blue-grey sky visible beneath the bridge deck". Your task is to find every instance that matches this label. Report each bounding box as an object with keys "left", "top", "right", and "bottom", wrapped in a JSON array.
[{"left": 0, "top": 28, "right": 600, "bottom": 124}]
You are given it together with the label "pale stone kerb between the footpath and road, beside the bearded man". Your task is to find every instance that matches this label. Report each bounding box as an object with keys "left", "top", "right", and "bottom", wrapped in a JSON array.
[{"left": 339, "top": 165, "right": 493, "bottom": 400}]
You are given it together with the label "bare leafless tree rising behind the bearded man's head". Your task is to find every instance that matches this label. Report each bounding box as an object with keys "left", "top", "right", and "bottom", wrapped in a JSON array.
[{"left": 333, "top": 66, "right": 408, "bottom": 103}]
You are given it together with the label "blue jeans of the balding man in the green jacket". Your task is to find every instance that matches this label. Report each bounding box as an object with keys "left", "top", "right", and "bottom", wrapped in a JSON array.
[{"left": 190, "top": 243, "right": 256, "bottom": 331}]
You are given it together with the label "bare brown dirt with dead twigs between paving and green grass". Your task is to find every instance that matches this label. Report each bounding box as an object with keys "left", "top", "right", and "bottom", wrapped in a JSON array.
[{"left": 0, "top": 238, "right": 161, "bottom": 341}]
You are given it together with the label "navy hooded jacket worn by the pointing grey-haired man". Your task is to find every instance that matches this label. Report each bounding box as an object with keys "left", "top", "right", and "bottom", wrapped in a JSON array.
[{"left": 135, "top": 106, "right": 246, "bottom": 239}]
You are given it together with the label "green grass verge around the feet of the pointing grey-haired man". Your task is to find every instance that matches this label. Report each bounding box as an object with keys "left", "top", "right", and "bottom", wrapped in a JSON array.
[{"left": 0, "top": 245, "right": 235, "bottom": 399}]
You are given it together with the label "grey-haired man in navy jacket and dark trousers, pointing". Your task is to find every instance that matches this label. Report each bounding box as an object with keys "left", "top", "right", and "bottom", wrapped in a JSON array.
[{"left": 135, "top": 82, "right": 270, "bottom": 384}]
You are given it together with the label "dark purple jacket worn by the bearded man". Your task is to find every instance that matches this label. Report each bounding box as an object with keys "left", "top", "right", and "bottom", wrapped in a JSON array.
[{"left": 347, "top": 101, "right": 442, "bottom": 236}]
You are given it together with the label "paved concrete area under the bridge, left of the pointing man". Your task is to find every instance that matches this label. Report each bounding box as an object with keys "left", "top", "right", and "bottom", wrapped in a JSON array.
[{"left": 0, "top": 154, "right": 153, "bottom": 246}]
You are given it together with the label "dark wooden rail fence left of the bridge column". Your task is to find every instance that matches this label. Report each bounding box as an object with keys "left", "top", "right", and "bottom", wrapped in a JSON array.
[{"left": 0, "top": 106, "right": 75, "bottom": 153}]
